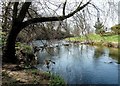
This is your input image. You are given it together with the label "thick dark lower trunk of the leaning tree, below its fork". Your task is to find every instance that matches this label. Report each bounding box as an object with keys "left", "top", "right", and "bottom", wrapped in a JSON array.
[{"left": 3, "top": 26, "right": 20, "bottom": 63}]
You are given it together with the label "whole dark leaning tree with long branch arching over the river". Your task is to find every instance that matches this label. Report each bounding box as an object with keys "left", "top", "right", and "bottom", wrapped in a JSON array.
[{"left": 3, "top": 0, "right": 91, "bottom": 63}]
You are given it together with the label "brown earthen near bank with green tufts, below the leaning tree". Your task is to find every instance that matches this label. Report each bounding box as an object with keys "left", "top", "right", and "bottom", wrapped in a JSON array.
[{"left": 2, "top": 64, "right": 65, "bottom": 86}]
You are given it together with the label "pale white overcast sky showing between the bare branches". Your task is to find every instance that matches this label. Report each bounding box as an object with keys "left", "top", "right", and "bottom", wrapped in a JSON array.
[{"left": 0, "top": 0, "right": 119, "bottom": 27}]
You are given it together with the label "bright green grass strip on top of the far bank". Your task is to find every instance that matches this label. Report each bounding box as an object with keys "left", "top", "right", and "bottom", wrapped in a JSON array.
[{"left": 65, "top": 34, "right": 120, "bottom": 42}]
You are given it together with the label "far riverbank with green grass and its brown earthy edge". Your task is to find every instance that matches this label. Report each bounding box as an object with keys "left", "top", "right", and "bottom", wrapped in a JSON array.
[{"left": 65, "top": 34, "right": 120, "bottom": 48}]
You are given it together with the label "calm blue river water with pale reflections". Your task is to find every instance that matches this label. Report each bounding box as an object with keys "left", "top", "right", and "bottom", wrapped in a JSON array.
[{"left": 34, "top": 41, "right": 119, "bottom": 84}]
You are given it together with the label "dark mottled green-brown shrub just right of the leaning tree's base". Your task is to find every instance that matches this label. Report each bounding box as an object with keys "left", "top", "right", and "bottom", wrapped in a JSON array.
[{"left": 15, "top": 42, "right": 37, "bottom": 68}]
